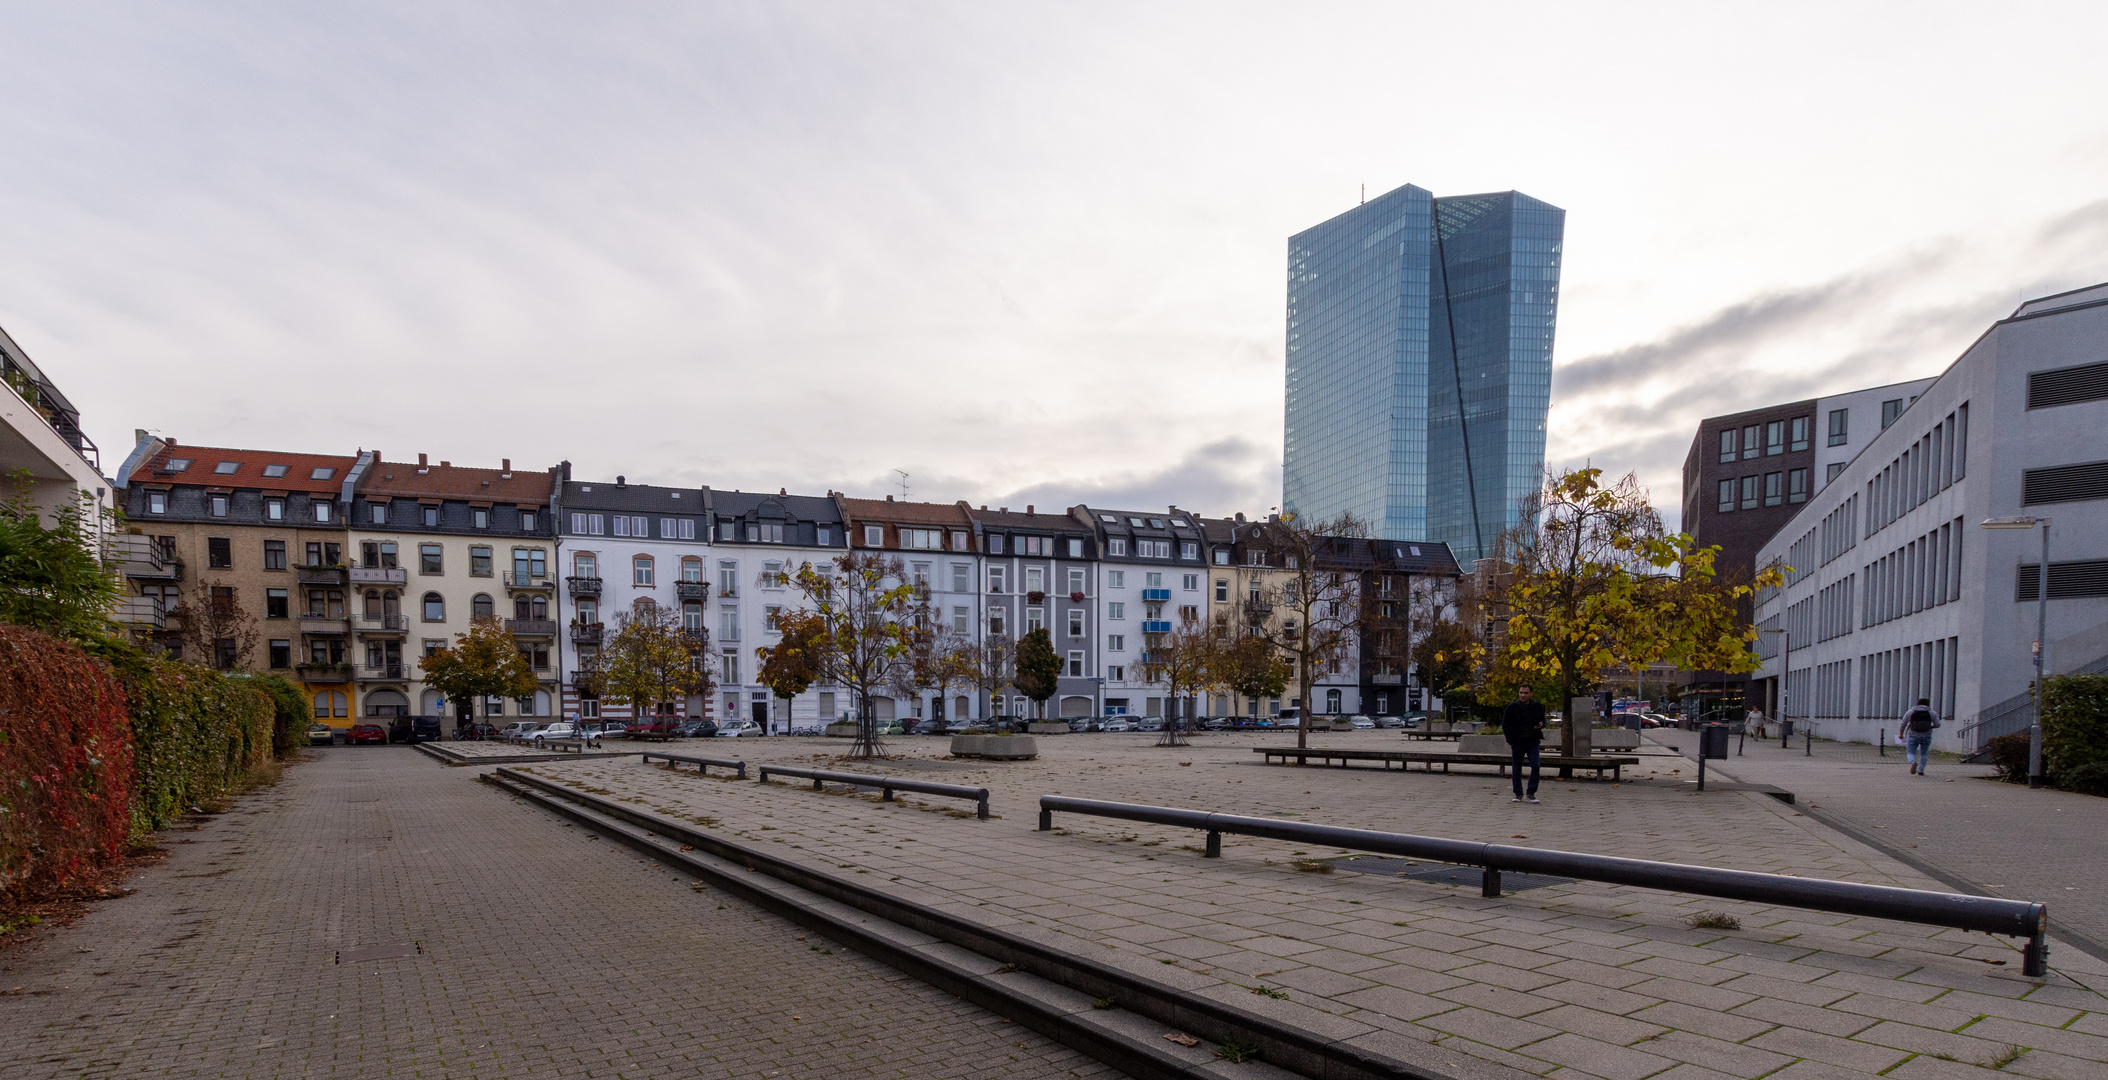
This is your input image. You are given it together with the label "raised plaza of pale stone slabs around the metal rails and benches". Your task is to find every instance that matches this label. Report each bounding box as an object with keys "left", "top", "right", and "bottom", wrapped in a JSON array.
[{"left": 510, "top": 732, "right": 2108, "bottom": 1080}]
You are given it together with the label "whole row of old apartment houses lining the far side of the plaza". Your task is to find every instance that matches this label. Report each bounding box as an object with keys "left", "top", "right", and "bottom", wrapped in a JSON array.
[{"left": 106, "top": 432, "right": 1459, "bottom": 732}]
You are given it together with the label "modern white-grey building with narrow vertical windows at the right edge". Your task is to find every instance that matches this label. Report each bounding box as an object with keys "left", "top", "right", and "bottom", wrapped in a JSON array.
[{"left": 1756, "top": 285, "right": 2108, "bottom": 751}]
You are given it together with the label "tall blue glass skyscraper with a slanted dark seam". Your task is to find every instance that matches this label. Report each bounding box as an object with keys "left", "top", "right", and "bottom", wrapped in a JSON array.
[{"left": 1282, "top": 184, "right": 1566, "bottom": 567}]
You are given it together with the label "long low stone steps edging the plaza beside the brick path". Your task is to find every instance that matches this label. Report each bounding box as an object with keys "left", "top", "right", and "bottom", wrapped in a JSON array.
[{"left": 481, "top": 768, "right": 1528, "bottom": 1080}]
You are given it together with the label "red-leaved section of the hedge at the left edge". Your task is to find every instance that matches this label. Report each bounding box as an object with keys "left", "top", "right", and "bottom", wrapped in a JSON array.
[{"left": 0, "top": 624, "right": 133, "bottom": 894}]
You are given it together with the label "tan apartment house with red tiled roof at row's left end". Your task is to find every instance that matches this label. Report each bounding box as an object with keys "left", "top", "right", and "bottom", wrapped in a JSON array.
[{"left": 114, "top": 442, "right": 360, "bottom": 719}]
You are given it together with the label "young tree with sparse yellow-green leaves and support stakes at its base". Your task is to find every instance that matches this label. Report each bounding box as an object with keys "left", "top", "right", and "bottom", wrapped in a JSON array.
[{"left": 791, "top": 551, "right": 915, "bottom": 757}]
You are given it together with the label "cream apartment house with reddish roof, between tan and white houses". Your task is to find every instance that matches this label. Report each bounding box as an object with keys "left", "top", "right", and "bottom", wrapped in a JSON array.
[{"left": 346, "top": 454, "right": 563, "bottom": 724}]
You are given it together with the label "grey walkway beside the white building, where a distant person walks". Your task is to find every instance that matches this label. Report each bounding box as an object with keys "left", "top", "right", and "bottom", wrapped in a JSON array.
[{"left": 1646, "top": 730, "right": 2108, "bottom": 960}]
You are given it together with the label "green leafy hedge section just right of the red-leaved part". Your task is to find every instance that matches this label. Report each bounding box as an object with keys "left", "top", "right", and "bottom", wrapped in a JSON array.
[{"left": 124, "top": 660, "right": 276, "bottom": 835}]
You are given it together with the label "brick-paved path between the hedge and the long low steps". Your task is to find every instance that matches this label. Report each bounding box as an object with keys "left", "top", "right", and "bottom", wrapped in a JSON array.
[{"left": 0, "top": 747, "right": 1115, "bottom": 1080}]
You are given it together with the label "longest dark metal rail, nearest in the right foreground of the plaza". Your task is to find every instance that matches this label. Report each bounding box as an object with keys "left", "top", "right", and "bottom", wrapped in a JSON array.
[{"left": 1039, "top": 795, "right": 2049, "bottom": 977}]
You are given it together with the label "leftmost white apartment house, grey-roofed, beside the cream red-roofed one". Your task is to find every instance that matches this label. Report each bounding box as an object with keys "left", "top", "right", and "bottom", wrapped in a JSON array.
[{"left": 552, "top": 476, "right": 717, "bottom": 721}]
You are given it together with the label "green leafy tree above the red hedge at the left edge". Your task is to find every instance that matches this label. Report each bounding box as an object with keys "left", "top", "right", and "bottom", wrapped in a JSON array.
[{"left": 0, "top": 470, "right": 122, "bottom": 652}]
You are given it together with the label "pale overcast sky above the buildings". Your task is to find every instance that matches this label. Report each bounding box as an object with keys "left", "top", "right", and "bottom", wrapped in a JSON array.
[{"left": 0, "top": 0, "right": 2108, "bottom": 523}]
